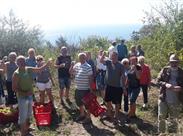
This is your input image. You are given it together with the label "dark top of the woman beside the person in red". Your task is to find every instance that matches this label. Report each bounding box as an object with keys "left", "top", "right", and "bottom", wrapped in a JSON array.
[{"left": 127, "top": 65, "right": 141, "bottom": 88}]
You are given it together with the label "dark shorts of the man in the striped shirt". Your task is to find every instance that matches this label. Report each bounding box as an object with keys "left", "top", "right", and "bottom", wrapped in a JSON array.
[{"left": 75, "top": 89, "right": 90, "bottom": 107}]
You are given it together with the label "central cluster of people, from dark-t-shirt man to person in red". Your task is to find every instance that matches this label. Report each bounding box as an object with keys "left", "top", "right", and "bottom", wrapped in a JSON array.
[{"left": 55, "top": 40, "right": 151, "bottom": 123}]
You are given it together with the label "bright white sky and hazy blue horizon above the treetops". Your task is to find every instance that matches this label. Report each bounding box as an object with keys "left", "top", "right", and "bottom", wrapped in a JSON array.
[{"left": 0, "top": 0, "right": 166, "bottom": 42}]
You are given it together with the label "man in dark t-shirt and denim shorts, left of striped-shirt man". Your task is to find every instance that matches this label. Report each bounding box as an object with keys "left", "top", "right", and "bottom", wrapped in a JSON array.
[{"left": 55, "top": 46, "right": 71, "bottom": 103}]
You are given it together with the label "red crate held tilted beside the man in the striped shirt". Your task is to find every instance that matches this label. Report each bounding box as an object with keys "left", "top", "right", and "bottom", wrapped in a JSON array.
[{"left": 82, "top": 93, "right": 106, "bottom": 117}]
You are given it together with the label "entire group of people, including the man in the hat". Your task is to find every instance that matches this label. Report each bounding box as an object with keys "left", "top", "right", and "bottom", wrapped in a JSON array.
[{"left": 0, "top": 40, "right": 183, "bottom": 135}]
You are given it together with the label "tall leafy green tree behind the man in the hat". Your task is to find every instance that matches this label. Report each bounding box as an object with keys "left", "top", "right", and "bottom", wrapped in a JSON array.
[{"left": 131, "top": 0, "right": 183, "bottom": 76}]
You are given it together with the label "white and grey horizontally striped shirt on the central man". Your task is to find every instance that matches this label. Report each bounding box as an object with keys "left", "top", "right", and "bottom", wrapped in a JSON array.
[{"left": 73, "top": 62, "right": 93, "bottom": 90}]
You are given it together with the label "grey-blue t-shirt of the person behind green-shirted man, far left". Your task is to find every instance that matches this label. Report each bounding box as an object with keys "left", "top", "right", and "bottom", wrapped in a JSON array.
[{"left": 6, "top": 62, "right": 18, "bottom": 82}]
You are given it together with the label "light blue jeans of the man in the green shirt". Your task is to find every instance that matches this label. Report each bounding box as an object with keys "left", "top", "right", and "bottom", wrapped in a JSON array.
[{"left": 18, "top": 96, "right": 33, "bottom": 125}]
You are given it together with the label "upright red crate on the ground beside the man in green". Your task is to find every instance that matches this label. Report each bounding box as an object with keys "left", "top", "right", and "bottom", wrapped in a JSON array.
[{"left": 33, "top": 103, "right": 53, "bottom": 126}]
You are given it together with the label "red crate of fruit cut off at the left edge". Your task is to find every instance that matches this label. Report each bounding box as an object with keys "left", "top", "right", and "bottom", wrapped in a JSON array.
[{"left": 0, "top": 107, "right": 18, "bottom": 124}]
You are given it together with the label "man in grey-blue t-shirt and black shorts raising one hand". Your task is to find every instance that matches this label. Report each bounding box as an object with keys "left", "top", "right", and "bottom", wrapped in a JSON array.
[{"left": 100, "top": 52, "right": 126, "bottom": 123}]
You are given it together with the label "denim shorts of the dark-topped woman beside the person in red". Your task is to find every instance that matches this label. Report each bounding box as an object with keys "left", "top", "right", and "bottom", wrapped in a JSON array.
[{"left": 129, "top": 87, "right": 140, "bottom": 104}]
